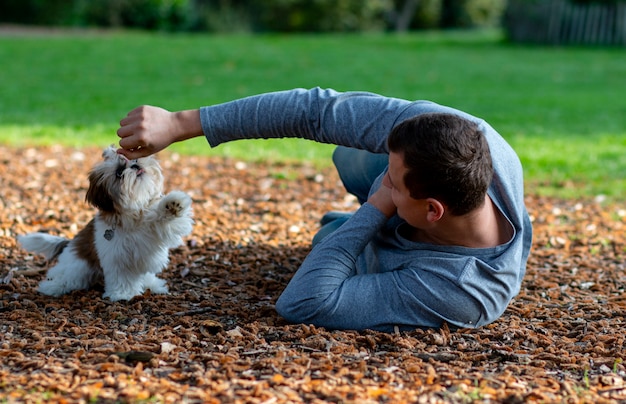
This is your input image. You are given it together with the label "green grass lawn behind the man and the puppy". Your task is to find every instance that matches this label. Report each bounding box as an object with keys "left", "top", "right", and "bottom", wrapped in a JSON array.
[{"left": 0, "top": 28, "right": 626, "bottom": 197}]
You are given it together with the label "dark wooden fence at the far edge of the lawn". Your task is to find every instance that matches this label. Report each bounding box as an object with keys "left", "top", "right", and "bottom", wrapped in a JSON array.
[{"left": 504, "top": 0, "right": 626, "bottom": 46}]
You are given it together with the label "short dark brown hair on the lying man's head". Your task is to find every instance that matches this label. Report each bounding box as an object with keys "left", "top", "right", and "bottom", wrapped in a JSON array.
[{"left": 387, "top": 113, "right": 493, "bottom": 216}]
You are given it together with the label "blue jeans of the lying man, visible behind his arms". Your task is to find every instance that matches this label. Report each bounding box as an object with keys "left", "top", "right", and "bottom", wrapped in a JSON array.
[{"left": 312, "top": 146, "right": 389, "bottom": 245}]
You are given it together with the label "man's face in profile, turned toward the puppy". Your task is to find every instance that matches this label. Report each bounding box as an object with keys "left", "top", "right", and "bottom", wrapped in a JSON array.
[{"left": 383, "top": 152, "right": 428, "bottom": 229}]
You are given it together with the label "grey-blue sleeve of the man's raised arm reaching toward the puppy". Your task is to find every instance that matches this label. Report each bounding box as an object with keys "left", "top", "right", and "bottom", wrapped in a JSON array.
[{"left": 200, "top": 88, "right": 411, "bottom": 153}]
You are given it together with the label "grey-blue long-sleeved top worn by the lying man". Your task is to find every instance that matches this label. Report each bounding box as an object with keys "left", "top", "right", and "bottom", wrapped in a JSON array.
[{"left": 200, "top": 88, "right": 532, "bottom": 331}]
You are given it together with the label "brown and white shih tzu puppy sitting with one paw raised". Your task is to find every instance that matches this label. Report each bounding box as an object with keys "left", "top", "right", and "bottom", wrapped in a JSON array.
[{"left": 18, "top": 146, "right": 193, "bottom": 301}]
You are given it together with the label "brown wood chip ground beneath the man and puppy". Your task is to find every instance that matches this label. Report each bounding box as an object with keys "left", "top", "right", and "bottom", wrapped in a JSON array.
[{"left": 0, "top": 147, "right": 626, "bottom": 403}]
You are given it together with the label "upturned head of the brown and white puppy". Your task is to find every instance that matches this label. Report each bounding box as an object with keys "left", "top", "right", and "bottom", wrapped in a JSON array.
[{"left": 85, "top": 147, "right": 163, "bottom": 214}]
